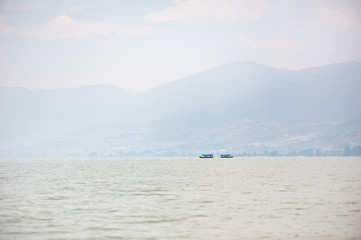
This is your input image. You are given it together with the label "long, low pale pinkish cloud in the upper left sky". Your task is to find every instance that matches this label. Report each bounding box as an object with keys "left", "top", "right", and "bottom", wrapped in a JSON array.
[{"left": 17, "top": 15, "right": 152, "bottom": 39}]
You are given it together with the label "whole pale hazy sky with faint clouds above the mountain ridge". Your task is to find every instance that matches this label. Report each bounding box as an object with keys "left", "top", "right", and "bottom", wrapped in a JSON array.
[{"left": 0, "top": 0, "right": 361, "bottom": 92}]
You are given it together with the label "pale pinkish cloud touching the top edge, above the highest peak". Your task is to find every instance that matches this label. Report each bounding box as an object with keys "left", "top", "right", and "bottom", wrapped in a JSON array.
[{"left": 146, "top": 0, "right": 267, "bottom": 22}]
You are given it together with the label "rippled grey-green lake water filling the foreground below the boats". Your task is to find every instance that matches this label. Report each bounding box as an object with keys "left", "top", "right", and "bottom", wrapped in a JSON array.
[{"left": 0, "top": 157, "right": 361, "bottom": 240}]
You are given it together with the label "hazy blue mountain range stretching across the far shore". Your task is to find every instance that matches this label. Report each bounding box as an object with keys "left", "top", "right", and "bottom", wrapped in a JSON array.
[{"left": 0, "top": 62, "right": 361, "bottom": 156}]
